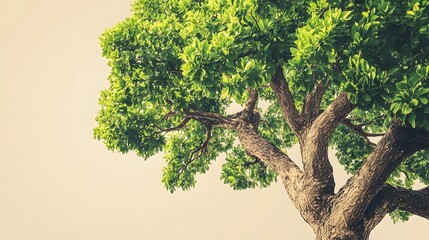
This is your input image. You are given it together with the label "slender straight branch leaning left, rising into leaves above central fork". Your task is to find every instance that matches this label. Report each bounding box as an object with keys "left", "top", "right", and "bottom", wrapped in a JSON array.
[{"left": 271, "top": 67, "right": 303, "bottom": 136}]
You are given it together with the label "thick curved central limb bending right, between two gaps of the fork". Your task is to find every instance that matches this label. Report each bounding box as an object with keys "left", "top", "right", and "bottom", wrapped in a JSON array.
[{"left": 301, "top": 94, "right": 353, "bottom": 194}]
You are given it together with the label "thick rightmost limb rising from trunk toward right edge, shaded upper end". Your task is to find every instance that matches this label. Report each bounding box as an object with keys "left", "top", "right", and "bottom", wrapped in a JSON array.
[{"left": 331, "top": 122, "right": 429, "bottom": 226}]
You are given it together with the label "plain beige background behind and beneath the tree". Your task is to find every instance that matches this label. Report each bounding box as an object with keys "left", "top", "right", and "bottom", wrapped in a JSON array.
[{"left": 0, "top": 0, "right": 429, "bottom": 240}]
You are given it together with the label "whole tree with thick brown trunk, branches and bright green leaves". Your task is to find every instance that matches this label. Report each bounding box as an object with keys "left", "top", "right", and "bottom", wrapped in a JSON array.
[{"left": 94, "top": 0, "right": 429, "bottom": 240}]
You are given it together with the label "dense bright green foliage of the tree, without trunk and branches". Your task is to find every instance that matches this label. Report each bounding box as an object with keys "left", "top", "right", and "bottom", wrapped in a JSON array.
[{"left": 94, "top": 0, "right": 429, "bottom": 223}]
